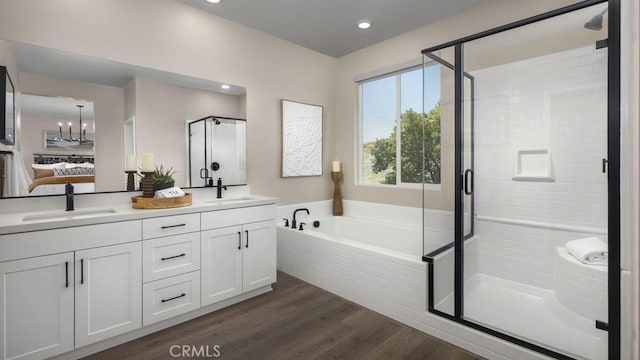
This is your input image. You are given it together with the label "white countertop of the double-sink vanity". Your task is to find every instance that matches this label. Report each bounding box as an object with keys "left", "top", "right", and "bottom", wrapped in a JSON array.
[{"left": 0, "top": 195, "right": 277, "bottom": 235}]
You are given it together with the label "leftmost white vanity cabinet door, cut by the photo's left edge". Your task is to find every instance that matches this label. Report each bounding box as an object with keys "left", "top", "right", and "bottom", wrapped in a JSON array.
[{"left": 0, "top": 253, "right": 73, "bottom": 359}]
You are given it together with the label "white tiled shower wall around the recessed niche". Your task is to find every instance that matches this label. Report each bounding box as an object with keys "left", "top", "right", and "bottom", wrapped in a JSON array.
[{"left": 465, "top": 47, "right": 607, "bottom": 302}]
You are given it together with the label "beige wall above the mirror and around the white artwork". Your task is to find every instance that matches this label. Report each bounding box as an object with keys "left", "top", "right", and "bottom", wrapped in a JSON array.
[{"left": 0, "top": 0, "right": 336, "bottom": 203}]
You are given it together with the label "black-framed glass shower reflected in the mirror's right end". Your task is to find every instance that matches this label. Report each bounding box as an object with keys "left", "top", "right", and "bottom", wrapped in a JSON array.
[{"left": 187, "top": 116, "right": 247, "bottom": 187}]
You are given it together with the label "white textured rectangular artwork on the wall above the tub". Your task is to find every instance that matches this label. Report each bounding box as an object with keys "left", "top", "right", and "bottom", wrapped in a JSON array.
[{"left": 282, "top": 100, "right": 322, "bottom": 177}]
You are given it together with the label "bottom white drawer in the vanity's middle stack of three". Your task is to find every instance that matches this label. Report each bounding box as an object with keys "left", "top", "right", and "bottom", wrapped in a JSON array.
[{"left": 142, "top": 271, "right": 200, "bottom": 326}]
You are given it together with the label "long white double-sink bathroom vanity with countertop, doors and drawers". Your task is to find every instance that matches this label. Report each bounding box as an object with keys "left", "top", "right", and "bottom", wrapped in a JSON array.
[{"left": 0, "top": 196, "right": 276, "bottom": 359}]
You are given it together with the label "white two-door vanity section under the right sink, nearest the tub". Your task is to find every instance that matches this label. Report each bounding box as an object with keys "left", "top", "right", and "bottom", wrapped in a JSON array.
[{"left": 201, "top": 205, "right": 276, "bottom": 306}]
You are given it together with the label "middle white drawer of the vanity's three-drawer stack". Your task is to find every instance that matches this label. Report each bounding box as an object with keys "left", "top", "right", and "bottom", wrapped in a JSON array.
[{"left": 142, "top": 232, "right": 200, "bottom": 282}]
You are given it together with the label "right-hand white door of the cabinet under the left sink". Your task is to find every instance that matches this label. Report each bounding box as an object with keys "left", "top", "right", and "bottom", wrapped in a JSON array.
[{"left": 75, "top": 242, "right": 142, "bottom": 347}]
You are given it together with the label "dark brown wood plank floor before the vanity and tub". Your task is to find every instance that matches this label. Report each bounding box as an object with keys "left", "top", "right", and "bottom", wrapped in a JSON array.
[{"left": 86, "top": 272, "right": 480, "bottom": 360}]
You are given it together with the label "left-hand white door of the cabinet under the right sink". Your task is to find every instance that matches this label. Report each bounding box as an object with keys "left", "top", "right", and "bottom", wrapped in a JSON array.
[{"left": 200, "top": 226, "right": 244, "bottom": 306}]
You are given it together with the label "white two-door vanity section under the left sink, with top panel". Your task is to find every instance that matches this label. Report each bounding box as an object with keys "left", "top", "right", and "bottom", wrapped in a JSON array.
[{"left": 0, "top": 221, "right": 142, "bottom": 359}]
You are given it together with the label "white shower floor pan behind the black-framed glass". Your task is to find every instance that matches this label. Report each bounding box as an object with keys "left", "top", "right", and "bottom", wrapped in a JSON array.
[{"left": 436, "top": 274, "right": 607, "bottom": 360}]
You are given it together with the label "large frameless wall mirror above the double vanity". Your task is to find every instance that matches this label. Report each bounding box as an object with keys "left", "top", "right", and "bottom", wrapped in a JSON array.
[{"left": 0, "top": 40, "right": 246, "bottom": 197}]
